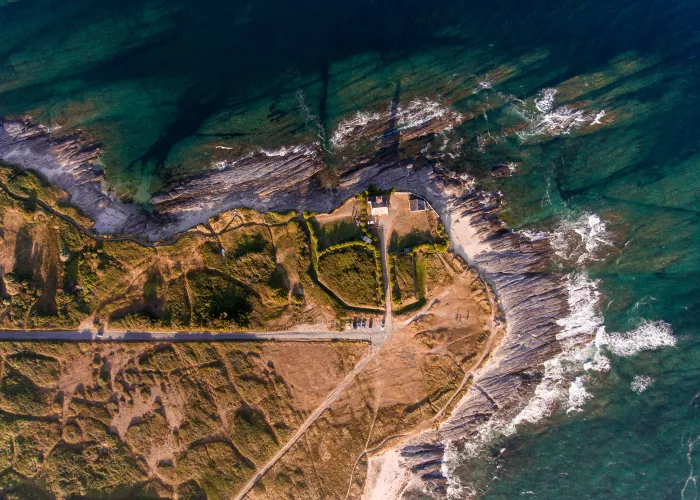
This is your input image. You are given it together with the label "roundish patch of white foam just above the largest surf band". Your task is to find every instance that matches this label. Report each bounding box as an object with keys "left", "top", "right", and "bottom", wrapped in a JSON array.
[{"left": 551, "top": 212, "right": 613, "bottom": 265}]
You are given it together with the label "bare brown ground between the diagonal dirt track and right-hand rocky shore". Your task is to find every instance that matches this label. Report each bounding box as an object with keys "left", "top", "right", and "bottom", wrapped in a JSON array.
[{"left": 250, "top": 266, "right": 492, "bottom": 500}]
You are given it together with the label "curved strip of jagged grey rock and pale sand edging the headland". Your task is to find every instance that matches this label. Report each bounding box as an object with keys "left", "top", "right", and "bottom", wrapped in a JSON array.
[{"left": 0, "top": 116, "right": 570, "bottom": 498}]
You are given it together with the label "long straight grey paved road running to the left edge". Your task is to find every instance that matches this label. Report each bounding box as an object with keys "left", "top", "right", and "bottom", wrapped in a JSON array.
[{"left": 0, "top": 330, "right": 378, "bottom": 342}]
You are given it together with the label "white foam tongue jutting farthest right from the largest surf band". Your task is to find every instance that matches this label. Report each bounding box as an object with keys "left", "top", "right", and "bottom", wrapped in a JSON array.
[{"left": 596, "top": 320, "right": 676, "bottom": 357}]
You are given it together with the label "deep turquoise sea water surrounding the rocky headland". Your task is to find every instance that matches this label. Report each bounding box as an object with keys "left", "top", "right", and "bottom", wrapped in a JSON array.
[{"left": 0, "top": 0, "right": 700, "bottom": 498}]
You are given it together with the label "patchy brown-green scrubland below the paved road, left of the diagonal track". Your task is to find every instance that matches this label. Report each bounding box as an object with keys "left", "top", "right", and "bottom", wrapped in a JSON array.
[{"left": 0, "top": 342, "right": 368, "bottom": 499}]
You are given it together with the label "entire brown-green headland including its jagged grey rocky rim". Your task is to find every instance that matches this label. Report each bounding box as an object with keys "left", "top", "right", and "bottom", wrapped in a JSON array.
[{"left": 0, "top": 115, "right": 580, "bottom": 498}]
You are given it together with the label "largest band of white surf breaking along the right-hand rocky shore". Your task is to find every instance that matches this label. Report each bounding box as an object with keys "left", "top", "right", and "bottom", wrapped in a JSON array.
[{"left": 442, "top": 270, "right": 676, "bottom": 498}]
